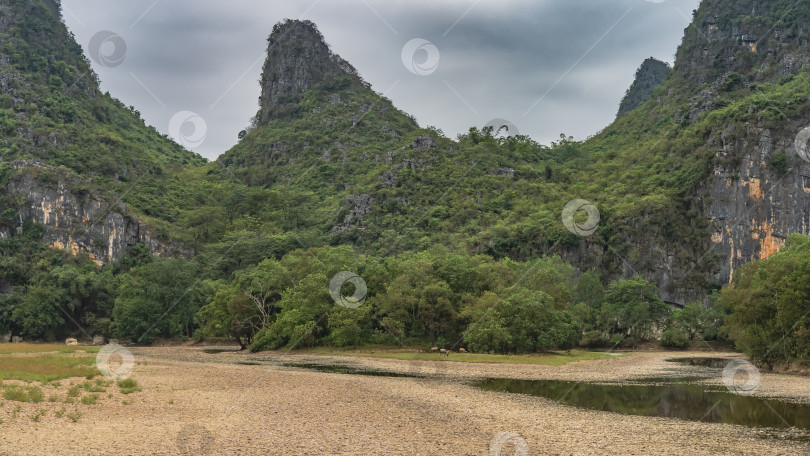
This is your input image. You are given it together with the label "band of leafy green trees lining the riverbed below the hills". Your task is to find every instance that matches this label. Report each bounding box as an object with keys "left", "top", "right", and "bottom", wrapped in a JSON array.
[{"left": 0, "top": 225, "right": 722, "bottom": 353}]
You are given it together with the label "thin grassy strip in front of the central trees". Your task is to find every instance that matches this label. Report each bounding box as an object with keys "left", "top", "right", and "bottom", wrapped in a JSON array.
[{"left": 300, "top": 347, "right": 615, "bottom": 366}]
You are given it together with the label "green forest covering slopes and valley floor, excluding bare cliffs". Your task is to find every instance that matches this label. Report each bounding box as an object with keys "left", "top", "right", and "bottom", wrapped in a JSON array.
[{"left": 0, "top": 0, "right": 810, "bottom": 374}]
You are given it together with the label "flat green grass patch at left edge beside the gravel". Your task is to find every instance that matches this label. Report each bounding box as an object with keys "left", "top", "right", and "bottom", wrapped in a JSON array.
[{"left": 0, "top": 353, "right": 100, "bottom": 382}]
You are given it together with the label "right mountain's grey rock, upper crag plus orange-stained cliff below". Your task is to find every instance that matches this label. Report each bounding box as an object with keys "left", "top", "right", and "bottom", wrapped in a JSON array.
[{"left": 675, "top": 0, "right": 810, "bottom": 283}]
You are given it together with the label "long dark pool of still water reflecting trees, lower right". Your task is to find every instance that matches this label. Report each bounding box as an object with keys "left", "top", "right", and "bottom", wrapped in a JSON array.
[{"left": 477, "top": 379, "right": 810, "bottom": 429}]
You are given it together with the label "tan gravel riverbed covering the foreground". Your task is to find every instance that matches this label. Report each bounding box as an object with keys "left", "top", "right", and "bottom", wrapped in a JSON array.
[{"left": 0, "top": 347, "right": 810, "bottom": 456}]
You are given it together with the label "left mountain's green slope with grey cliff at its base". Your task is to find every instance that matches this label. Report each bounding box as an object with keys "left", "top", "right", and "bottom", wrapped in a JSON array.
[{"left": 0, "top": 0, "right": 206, "bottom": 262}]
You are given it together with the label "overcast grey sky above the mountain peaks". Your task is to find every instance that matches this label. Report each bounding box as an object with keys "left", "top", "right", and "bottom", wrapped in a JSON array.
[{"left": 62, "top": 0, "right": 699, "bottom": 159}]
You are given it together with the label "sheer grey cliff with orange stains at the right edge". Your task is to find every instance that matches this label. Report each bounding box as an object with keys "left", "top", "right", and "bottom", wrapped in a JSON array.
[{"left": 700, "top": 120, "right": 810, "bottom": 283}]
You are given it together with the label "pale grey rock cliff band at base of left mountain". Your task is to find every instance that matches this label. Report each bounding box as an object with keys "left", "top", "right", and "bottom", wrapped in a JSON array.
[{"left": 0, "top": 161, "right": 191, "bottom": 264}]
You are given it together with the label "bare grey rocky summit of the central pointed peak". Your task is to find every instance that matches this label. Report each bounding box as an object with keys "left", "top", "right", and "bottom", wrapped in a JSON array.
[{"left": 257, "top": 20, "right": 360, "bottom": 124}]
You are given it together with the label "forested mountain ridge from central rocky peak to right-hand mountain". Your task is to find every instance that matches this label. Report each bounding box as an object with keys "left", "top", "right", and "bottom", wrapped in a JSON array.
[{"left": 4, "top": 0, "right": 810, "bottom": 304}]
